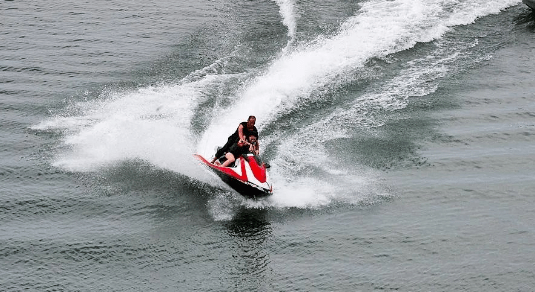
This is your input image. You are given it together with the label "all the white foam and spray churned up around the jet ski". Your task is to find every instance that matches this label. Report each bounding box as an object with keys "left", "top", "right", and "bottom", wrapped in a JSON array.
[{"left": 33, "top": 0, "right": 519, "bottom": 212}]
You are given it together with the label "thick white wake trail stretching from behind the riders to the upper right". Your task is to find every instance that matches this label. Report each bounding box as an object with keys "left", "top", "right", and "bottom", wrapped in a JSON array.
[{"left": 199, "top": 0, "right": 518, "bottom": 153}]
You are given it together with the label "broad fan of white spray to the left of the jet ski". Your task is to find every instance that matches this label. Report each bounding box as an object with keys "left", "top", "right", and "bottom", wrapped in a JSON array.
[{"left": 33, "top": 78, "right": 226, "bottom": 181}]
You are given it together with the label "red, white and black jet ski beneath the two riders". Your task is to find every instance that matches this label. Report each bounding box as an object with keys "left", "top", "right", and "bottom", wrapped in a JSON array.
[{"left": 193, "top": 153, "right": 273, "bottom": 199}]
